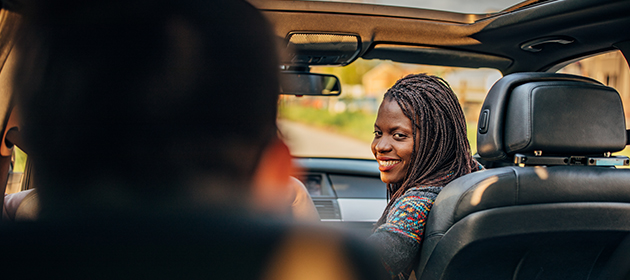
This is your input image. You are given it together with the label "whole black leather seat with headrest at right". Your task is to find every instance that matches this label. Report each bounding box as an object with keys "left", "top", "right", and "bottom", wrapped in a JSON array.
[{"left": 417, "top": 73, "right": 630, "bottom": 280}]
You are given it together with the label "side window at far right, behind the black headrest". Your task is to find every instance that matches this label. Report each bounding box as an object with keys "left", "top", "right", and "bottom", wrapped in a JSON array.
[{"left": 558, "top": 51, "right": 630, "bottom": 160}]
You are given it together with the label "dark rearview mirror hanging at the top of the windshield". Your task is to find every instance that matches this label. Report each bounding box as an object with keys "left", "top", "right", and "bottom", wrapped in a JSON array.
[{"left": 280, "top": 72, "right": 341, "bottom": 96}]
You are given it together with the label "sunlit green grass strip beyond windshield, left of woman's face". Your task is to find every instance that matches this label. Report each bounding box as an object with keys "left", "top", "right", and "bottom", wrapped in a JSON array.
[{"left": 279, "top": 105, "right": 376, "bottom": 143}]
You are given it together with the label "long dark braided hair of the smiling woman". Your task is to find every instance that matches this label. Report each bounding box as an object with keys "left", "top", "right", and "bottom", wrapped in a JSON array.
[{"left": 376, "top": 74, "right": 478, "bottom": 227}]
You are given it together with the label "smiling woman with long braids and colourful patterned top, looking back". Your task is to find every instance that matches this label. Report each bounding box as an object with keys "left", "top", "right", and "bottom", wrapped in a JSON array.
[{"left": 370, "top": 74, "right": 482, "bottom": 280}]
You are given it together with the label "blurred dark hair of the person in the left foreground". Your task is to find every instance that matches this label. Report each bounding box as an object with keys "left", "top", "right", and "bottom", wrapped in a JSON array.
[{"left": 15, "top": 0, "right": 279, "bottom": 215}]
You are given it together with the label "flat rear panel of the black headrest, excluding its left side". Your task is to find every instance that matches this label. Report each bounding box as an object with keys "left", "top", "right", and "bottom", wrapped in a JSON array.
[{"left": 504, "top": 81, "right": 626, "bottom": 156}]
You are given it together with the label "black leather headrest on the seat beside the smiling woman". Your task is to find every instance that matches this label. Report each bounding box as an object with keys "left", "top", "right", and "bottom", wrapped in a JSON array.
[{"left": 477, "top": 73, "right": 626, "bottom": 161}]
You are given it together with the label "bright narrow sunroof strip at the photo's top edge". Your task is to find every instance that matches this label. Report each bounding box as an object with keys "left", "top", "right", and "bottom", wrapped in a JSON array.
[{"left": 306, "top": 0, "right": 523, "bottom": 14}]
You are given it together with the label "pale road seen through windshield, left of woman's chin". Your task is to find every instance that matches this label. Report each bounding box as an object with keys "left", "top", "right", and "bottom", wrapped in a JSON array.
[{"left": 278, "top": 120, "right": 374, "bottom": 159}]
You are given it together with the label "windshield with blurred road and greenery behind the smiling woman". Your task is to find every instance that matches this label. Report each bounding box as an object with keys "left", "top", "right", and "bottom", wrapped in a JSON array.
[{"left": 278, "top": 59, "right": 501, "bottom": 159}]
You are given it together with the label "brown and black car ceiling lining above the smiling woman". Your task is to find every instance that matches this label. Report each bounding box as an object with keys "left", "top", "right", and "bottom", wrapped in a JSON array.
[{"left": 249, "top": 0, "right": 630, "bottom": 74}]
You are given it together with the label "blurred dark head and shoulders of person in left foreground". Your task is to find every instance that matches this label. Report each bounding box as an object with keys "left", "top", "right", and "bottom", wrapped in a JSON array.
[{"left": 7, "top": 3, "right": 390, "bottom": 279}]
